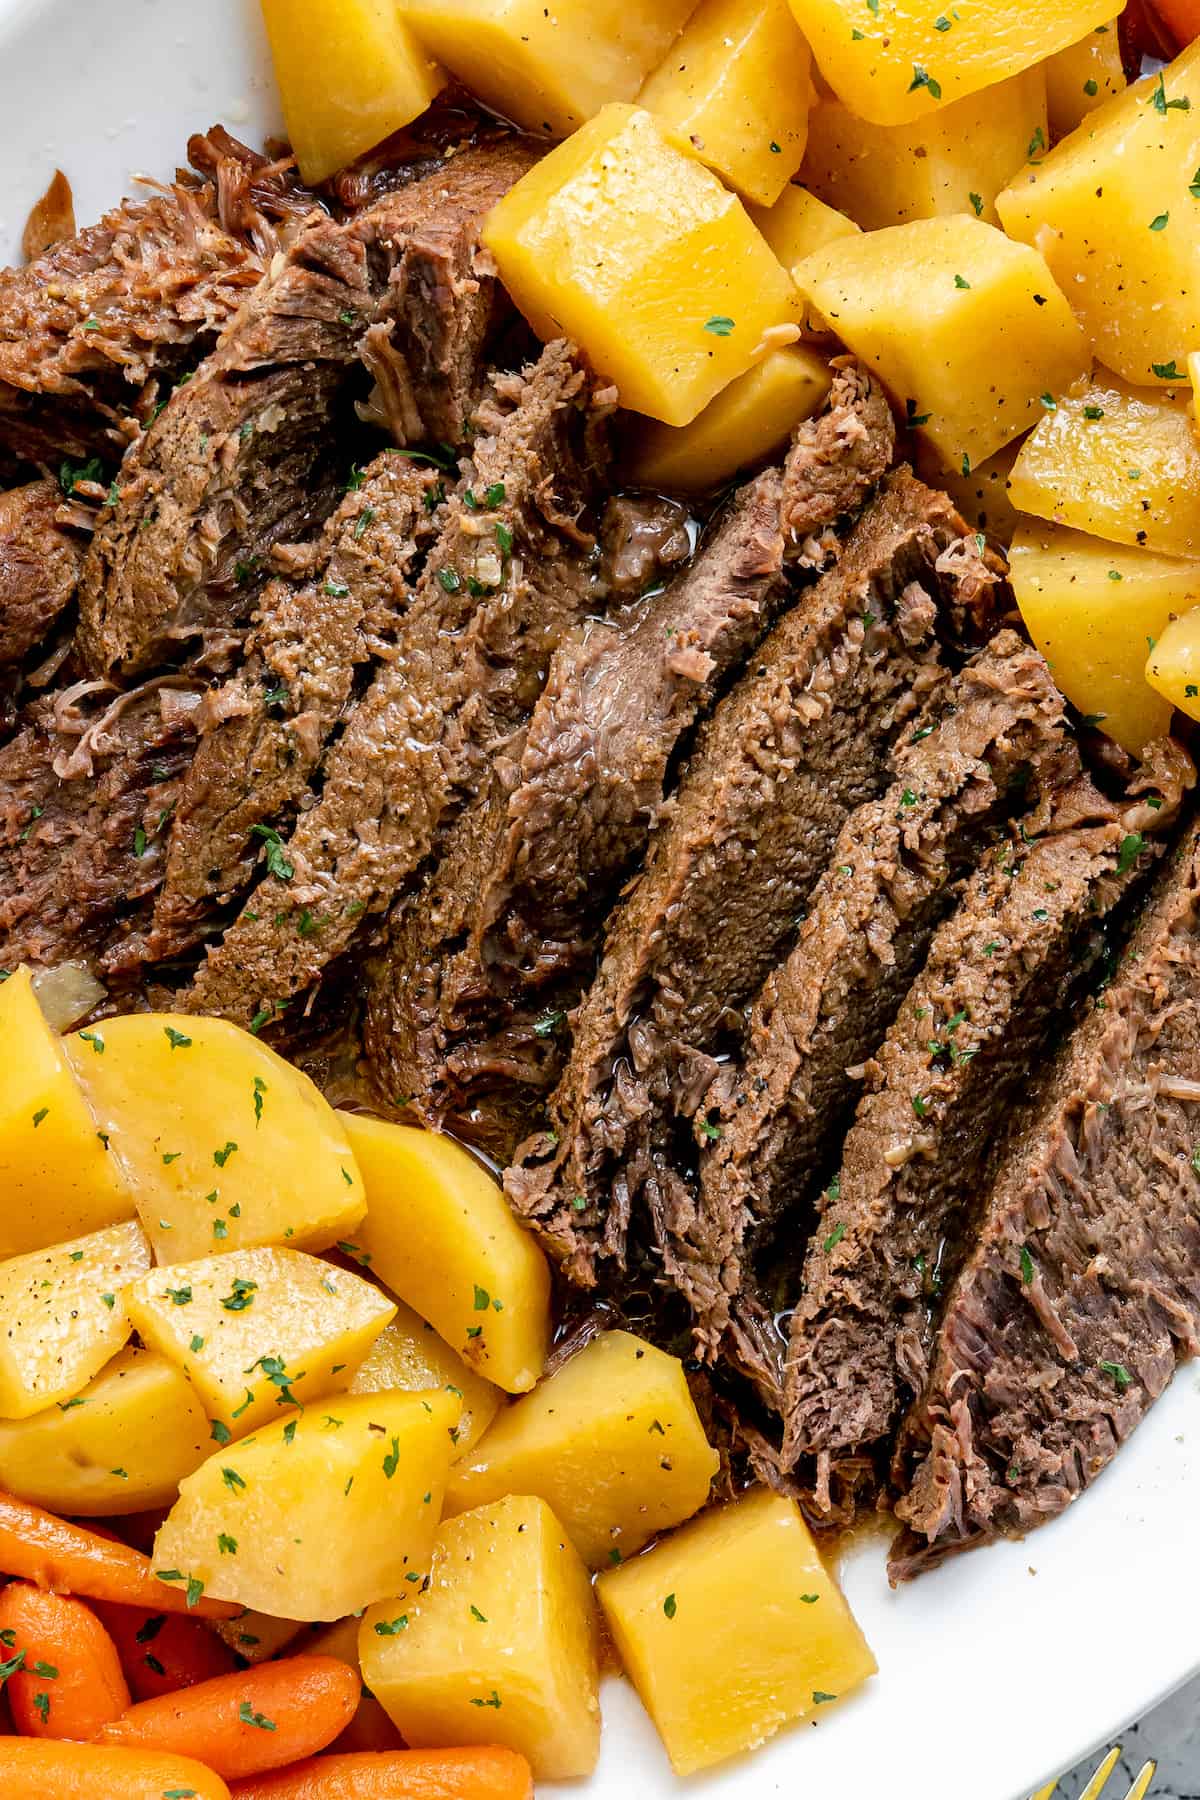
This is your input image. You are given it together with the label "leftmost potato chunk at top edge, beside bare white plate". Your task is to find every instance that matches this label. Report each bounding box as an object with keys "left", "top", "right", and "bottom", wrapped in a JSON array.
[{"left": 263, "top": 0, "right": 446, "bottom": 182}]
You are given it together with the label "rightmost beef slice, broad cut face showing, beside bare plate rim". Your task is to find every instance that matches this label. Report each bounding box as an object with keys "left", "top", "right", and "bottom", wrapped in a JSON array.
[{"left": 891, "top": 810, "right": 1200, "bottom": 1580}]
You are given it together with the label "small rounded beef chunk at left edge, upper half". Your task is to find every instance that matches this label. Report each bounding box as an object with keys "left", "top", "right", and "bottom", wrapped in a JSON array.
[{"left": 0, "top": 481, "right": 83, "bottom": 670}]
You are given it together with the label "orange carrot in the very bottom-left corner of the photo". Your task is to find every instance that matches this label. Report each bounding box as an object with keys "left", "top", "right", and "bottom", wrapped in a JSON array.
[{"left": 0, "top": 1737, "right": 228, "bottom": 1800}]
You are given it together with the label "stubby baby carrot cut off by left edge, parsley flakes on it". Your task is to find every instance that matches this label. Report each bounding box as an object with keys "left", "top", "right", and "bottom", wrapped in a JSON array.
[{"left": 0, "top": 1580, "right": 130, "bottom": 1742}]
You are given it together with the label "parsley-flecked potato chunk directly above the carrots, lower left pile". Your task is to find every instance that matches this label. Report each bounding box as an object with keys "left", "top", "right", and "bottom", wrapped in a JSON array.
[{"left": 155, "top": 1393, "right": 459, "bottom": 1622}]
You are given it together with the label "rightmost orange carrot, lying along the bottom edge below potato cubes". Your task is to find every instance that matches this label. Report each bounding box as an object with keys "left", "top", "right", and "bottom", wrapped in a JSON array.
[{"left": 228, "top": 1748, "right": 533, "bottom": 1800}]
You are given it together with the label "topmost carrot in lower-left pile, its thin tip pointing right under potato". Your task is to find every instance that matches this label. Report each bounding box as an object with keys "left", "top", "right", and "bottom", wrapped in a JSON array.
[{"left": 0, "top": 1492, "right": 241, "bottom": 1618}]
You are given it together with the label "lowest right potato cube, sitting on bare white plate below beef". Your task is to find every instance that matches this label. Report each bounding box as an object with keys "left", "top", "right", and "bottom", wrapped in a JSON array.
[{"left": 597, "top": 1489, "right": 876, "bottom": 1775}]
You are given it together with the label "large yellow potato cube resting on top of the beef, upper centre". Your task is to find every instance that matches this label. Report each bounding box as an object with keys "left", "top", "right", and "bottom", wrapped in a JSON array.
[{"left": 484, "top": 106, "right": 797, "bottom": 425}]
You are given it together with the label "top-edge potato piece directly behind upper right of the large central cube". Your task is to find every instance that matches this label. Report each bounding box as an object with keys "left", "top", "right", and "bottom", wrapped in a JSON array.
[{"left": 637, "top": 0, "right": 813, "bottom": 207}]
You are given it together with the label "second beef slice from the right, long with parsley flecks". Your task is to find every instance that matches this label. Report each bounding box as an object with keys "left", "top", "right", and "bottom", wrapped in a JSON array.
[{"left": 784, "top": 748, "right": 1178, "bottom": 1465}]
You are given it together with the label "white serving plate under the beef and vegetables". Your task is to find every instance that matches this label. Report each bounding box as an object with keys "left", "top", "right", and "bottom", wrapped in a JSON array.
[{"left": 0, "top": 0, "right": 1200, "bottom": 1800}]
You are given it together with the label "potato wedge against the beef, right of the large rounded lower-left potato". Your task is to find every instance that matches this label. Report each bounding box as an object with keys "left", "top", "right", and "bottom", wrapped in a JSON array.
[{"left": 342, "top": 1112, "right": 551, "bottom": 1393}]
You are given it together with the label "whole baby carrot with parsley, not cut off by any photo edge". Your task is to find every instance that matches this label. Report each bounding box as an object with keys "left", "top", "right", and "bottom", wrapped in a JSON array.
[{"left": 97, "top": 1656, "right": 360, "bottom": 1780}]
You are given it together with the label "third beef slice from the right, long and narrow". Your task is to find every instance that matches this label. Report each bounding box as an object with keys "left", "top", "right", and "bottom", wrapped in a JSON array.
[{"left": 689, "top": 632, "right": 1079, "bottom": 1404}]
